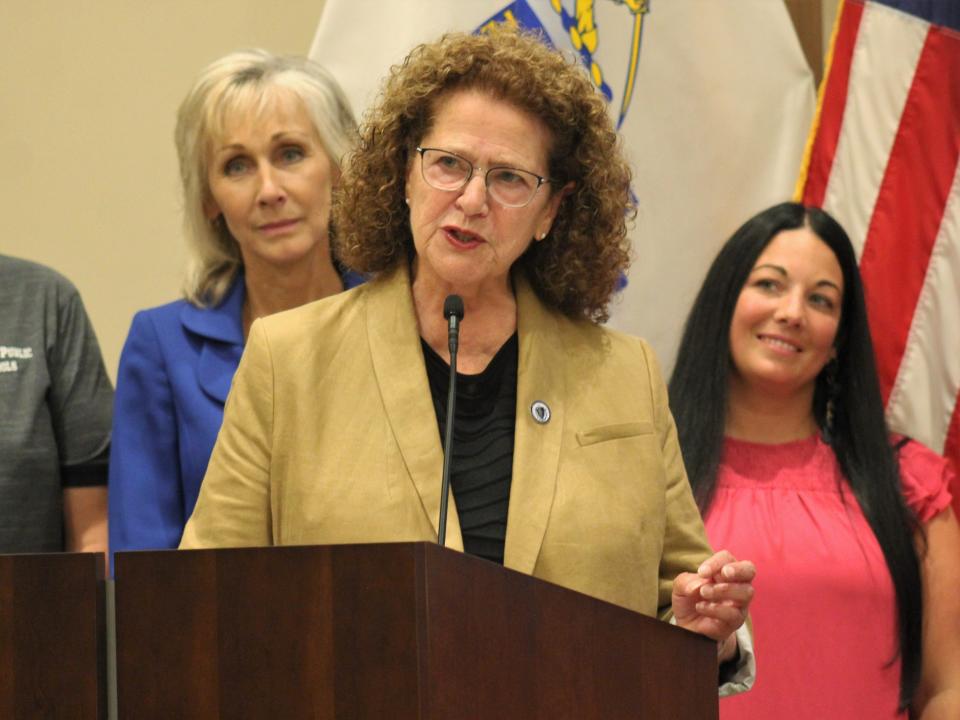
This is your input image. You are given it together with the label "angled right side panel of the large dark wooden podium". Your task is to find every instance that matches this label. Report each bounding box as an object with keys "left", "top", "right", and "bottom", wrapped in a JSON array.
[{"left": 422, "top": 545, "right": 717, "bottom": 720}]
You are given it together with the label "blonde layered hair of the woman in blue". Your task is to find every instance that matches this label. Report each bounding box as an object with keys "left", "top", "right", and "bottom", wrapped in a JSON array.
[{"left": 175, "top": 49, "right": 356, "bottom": 307}]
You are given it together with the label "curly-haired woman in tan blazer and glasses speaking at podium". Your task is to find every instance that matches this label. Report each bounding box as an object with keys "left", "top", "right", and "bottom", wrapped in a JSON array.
[{"left": 181, "top": 29, "right": 754, "bottom": 689}]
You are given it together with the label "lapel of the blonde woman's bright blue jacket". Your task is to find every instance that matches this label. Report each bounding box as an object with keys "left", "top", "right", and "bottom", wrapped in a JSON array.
[{"left": 180, "top": 275, "right": 245, "bottom": 405}]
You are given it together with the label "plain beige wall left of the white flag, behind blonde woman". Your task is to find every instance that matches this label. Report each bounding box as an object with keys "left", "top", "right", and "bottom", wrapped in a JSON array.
[{"left": 0, "top": 0, "right": 324, "bottom": 377}]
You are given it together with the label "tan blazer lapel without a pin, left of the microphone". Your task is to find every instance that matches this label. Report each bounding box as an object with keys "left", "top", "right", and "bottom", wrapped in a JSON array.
[{"left": 366, "top": 265, "right": 463, "bottom": 551}]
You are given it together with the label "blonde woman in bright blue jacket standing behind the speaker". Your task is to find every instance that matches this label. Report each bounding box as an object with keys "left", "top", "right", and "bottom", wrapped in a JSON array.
[{"left": 109, "top": 50, "right": 359, "bottom": 552}]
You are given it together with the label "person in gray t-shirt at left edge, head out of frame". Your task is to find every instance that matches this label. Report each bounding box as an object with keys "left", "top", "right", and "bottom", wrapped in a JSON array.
[{"left": 0, "top": 255, "right": 113, "bottom": 553}]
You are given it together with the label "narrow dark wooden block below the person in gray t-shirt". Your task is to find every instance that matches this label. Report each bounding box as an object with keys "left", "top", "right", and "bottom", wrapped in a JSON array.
[{"left": 0, "top": 553, "right": 107, "bottom": 720}]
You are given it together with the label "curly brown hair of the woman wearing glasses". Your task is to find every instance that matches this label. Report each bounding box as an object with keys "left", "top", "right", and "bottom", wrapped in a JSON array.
[{"left": 333, "top": 26, "right": 634, "bottom": 322}]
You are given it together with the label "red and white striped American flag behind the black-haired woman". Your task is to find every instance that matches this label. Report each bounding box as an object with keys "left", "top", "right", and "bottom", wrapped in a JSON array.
[{"left": 798, "top": 0, "right": 960, "bottom": 512}]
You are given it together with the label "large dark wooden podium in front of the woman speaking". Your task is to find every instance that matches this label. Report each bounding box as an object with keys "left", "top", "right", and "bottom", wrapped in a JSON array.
[{"left": 115, "top": 543, "right": 717, "bottom": 720}]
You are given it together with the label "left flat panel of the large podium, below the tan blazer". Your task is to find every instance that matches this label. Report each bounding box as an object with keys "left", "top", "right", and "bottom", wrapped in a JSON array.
[{"left": 115, "top": 545, "right": 417, "bottom": 720}]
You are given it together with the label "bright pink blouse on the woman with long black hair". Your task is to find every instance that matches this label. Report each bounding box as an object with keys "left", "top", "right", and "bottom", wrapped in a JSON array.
[{"left": 705, "top": 436, "right": 951, "bottom": 720}]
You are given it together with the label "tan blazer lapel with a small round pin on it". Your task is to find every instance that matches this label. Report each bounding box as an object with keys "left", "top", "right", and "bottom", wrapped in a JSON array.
[{"left": 504, "top": 272, "right": 567, "bottom": 575}]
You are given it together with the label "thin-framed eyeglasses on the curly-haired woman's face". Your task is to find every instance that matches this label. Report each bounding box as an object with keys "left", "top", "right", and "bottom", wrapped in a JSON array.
[{"left": 417, "top": 147, "right": 551, "bottom": 207}]
